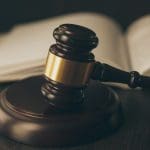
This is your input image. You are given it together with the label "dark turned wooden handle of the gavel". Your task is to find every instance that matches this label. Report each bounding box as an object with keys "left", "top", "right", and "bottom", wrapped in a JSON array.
[{"left": 91, "top": 62, "right": 150, "bottom": 88}]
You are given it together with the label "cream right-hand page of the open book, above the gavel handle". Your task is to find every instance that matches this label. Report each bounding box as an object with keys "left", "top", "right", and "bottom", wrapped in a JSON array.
[{"left": 126, "top": 15, "right": 150, "bottom": 75}]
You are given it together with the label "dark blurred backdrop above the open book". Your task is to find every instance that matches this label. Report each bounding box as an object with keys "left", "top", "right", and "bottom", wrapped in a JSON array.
[{"left": 0, "top": 0, "right": 150, "bottom": 31}]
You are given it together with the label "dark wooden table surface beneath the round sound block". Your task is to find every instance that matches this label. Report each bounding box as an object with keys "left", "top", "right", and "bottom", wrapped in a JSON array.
[{"left": 0, "top": 83, "right": 150, "bottom": 150}]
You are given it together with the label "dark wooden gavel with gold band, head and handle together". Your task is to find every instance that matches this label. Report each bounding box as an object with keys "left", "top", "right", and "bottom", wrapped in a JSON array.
[{"left": 42, "top": 24, "right": 150, "bottom": 108}]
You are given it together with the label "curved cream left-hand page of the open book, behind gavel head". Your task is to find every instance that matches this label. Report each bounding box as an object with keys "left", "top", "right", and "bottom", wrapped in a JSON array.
[{"left": 0, "top": 13, "right": 128, "bottom": 81}]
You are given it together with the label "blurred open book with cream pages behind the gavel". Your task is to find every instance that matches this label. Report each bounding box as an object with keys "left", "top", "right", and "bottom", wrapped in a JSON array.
[{"left": 0, "top": 13, "right": 150, "bottom": 82}]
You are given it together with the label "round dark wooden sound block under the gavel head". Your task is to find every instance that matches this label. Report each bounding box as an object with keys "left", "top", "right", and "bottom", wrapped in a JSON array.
[{"left": 0, "top": 76, "right": 123, "bottom": 147}]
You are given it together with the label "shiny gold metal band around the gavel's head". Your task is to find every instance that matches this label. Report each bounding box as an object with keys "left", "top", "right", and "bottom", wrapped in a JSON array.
[{"left": 45, "top": 52, "right": 94, "bottom": 87}]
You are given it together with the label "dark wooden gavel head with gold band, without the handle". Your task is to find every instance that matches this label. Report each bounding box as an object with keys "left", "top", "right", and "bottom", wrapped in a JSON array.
[{"left": 42, "top": 24, "right": 98, "bottom": 110}]
